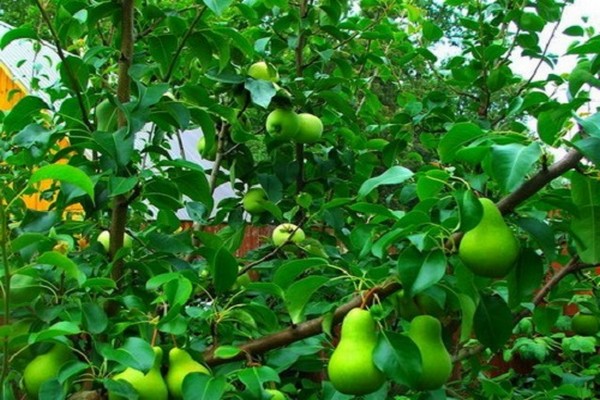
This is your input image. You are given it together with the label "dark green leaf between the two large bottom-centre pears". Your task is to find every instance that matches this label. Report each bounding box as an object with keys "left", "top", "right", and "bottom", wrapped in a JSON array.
[{"left": 373, "top": 331, "right": 422, "bottom": 387}]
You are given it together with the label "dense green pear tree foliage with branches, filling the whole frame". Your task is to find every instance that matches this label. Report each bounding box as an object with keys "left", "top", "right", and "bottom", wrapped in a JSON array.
[{"left": 0, "top": 0, "right": 600, "bottom": 399}]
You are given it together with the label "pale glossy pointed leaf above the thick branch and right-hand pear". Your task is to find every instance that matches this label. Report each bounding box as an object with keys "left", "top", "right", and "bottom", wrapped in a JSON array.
[{"left": 491, "top": 142, "right": 542, "bottom": 192}]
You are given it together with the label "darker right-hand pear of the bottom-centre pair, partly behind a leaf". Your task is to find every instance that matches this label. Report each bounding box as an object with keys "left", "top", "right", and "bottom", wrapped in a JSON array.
[{"left": 408, "top": 315, "right": 452, "bottom": 390}]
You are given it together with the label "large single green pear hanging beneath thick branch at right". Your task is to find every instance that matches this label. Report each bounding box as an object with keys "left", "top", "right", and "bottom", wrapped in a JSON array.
[{"left": 458, "top": 198, "right": 519, "bottom": 278}]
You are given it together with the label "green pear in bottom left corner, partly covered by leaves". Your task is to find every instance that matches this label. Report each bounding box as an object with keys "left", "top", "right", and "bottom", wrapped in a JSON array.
[{"left": 23, "top": 343, "right": 73, "bottom": 399}]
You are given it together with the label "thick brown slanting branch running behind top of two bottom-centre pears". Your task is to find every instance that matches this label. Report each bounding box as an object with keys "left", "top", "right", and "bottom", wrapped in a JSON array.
[{"left": 204, "top": 282, "right": 402, "bottom": 366}]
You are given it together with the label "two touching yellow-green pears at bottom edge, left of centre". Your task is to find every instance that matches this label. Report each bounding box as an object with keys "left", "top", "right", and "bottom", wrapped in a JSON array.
[{"left": 108, "top": 346, "right": 210, "bottom": 400}]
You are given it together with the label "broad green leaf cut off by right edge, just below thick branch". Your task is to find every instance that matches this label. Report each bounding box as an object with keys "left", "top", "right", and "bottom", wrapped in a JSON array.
[{"left": 571, "top": 206, "right": 600, "bottom": 264}]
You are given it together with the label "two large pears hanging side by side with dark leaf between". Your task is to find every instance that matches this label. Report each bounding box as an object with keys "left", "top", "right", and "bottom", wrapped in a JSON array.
[{"left": 327, "top": 308, "right": 452, "bottom": 396}]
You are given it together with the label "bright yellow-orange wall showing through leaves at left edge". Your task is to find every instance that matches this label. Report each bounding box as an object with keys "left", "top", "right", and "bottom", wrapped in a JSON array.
[{"left": 0, "top": 60, "right": 83, "bottom": 214}]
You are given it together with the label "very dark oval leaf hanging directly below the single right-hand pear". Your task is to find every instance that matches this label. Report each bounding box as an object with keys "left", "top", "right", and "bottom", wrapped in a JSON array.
[{"left": 473, "top": 294, "right": 513, "bottom": 352}]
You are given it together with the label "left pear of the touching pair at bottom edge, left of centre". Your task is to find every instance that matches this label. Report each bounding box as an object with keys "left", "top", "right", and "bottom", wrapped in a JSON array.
[{"left": 108, "top": 346, "right": 169, "bottom": 400}]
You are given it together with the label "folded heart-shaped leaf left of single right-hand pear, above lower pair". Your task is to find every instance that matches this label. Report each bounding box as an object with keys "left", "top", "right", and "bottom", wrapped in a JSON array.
[{"left": 398, "top": 246, "right": 446, "bottom": 296}]
